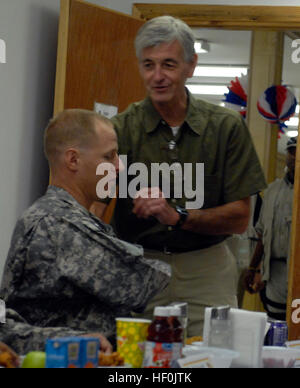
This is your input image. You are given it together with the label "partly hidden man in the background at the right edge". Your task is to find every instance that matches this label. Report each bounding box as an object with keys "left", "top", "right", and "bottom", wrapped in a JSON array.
[{"left": 245, "top": 138, "right": 297, "bottom": 321}]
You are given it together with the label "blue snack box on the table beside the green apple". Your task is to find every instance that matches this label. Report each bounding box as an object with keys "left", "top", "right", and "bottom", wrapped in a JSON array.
[{"left": 46, "top": 337, "right": 100, "bottom": 369}]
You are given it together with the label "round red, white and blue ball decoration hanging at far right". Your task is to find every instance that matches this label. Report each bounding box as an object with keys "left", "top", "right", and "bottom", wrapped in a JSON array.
[{"left": 257, "top": 85, "right": 297, "bottom": 133}]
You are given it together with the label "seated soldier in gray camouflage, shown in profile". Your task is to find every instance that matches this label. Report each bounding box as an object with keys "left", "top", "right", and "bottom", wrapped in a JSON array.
[{"left": 0, "top": 110, "right": 170, "bottom": 348}]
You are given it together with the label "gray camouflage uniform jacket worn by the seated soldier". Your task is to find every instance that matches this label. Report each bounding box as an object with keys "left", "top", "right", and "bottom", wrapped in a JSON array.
[{"left": 0, "top": 186, "right": 170, "bottom": 350}]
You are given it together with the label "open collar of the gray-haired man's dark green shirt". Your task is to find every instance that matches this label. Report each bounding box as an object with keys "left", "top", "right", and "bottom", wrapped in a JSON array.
[{"left": 142, "top": 89, "right": 207, "bottom": 135}]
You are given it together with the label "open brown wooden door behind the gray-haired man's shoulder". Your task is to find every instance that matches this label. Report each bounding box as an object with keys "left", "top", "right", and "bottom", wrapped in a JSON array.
[{"left": 54, "top": 0, "right": 146, "bottom": 222}]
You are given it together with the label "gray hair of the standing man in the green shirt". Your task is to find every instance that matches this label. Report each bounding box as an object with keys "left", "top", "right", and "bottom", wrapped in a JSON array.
[{"left": 135, "top": 16, "right": 195, "bottom": 63}]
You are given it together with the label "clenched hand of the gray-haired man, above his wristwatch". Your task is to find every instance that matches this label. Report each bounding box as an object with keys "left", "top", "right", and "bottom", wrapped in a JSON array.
[{"left": 133, "top": 187, "right": 180, "bottom": 225}]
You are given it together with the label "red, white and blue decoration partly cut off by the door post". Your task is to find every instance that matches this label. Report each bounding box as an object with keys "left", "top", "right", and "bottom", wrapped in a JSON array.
[{"left": 223, "top": 75, "right": 248, "bottom": 117}]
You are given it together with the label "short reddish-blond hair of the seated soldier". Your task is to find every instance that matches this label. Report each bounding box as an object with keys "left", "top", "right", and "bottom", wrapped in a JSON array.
[{"left": 44, "top": 109, "right": 113, "bottom": 164}]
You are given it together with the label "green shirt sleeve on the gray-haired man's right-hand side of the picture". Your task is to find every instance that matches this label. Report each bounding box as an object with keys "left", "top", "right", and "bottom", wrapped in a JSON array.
[{"left": 224, "top": 117, "right": 266, "bottom": 203}]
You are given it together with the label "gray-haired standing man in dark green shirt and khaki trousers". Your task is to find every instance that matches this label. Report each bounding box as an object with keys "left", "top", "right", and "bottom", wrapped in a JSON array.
[{"left": 95, "top": 16, "right": 265, "bottom": 336}]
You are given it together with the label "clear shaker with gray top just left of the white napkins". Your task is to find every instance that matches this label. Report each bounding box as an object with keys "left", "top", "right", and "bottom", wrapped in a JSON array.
[{"left": 208, "top": 306, "right": 233, "bottom": 349}]
